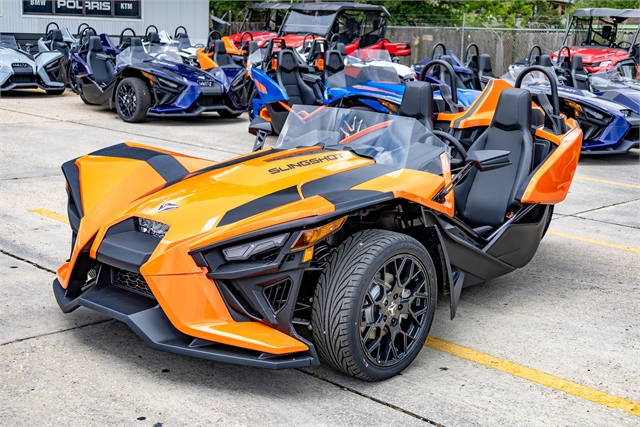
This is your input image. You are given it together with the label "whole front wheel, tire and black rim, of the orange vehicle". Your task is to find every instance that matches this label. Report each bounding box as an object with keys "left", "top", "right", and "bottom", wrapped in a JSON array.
[{"left": 312, "top": 230, "right": 437, "bottom": 381}]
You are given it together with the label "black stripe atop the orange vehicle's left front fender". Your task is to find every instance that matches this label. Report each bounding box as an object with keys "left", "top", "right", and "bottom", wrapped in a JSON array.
[{"left": 91, "top": 144, "right": 189, "bottom": 182}]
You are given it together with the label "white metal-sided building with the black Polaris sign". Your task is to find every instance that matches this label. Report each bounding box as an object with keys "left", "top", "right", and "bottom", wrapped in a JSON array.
[{"left": 0, "top": 0, "right": 209, "bottom": 48}]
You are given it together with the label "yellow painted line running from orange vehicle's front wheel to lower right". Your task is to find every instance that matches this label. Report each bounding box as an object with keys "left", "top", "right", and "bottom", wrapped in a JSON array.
[{"left": 425, "top": 337, "right": 640, "bottom": 417}]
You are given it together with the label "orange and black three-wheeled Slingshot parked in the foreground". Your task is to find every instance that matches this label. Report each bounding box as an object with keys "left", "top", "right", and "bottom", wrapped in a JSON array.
[{"left": 53, "top": 73, "right": 582, "bottom": 381}]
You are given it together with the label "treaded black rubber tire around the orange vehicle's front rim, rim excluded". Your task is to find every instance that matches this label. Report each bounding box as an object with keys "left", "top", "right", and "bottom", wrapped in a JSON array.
[{"left": 312, "top": 229, "right": 437, "bottom": 381}]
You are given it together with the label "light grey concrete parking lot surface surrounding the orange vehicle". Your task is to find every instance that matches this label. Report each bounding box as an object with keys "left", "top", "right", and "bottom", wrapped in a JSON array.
[{"left": 0, "top": 91, "right": 640, "bottom": 427}]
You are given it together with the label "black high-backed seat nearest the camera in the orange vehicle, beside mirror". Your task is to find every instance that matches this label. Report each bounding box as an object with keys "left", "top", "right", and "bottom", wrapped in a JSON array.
[{"left": 454, "top": 89, "right": 533, "bottom": 237}]
